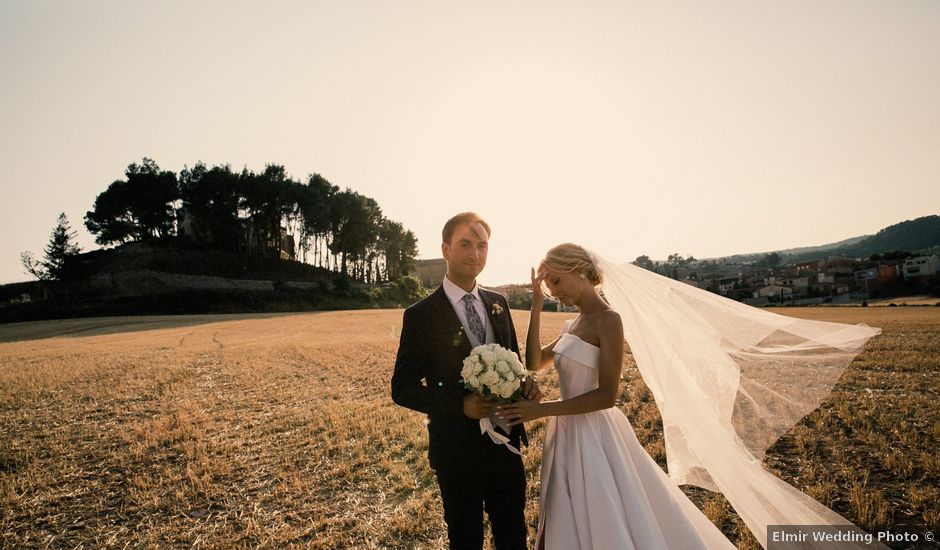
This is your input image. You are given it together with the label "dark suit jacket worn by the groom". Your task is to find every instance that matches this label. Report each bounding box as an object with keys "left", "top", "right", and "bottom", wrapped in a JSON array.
[{"left": 392, "top": 286, "right": 528, "bottom": 469}]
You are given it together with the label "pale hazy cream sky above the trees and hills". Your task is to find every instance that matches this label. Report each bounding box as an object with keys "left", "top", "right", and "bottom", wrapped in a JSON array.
[{"left": 0, "top": 0, "right": 940, "bottom": 284}]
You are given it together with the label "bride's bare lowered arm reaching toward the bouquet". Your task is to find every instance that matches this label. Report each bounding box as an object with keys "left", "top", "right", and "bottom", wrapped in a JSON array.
[{"left": 497, "top": 311, "right": 623, "bottom": 426}]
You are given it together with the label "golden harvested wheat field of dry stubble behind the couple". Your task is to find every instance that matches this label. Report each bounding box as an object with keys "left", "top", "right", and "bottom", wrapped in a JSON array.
[{"left": 0, "top": 307, "right": 940, "bottom": 548}]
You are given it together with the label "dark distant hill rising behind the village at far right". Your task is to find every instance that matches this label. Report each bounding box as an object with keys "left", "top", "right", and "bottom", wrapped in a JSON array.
[{"left": 714, "top": 216, "right": 940, "bottom": 263}]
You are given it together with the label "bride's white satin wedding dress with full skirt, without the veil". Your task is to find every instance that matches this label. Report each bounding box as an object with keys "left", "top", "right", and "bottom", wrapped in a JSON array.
[{"left": 536, "top": 321, "right": 734, "bottom": 550}]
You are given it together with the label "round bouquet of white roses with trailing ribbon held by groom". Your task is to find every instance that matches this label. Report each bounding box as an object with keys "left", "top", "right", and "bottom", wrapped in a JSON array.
[{"left": 460, "top": 344, "right": 529, "bottom": 454}]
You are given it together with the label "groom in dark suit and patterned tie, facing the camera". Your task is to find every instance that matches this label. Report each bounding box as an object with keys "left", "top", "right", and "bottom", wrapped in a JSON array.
[{"left": 392, "top": 212, "right": 539, "bottom": 550}]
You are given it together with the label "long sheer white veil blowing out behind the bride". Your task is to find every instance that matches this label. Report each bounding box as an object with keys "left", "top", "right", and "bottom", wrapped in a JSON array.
[{"left": 590, "top": 252, "right": 881, "bottom": 548}]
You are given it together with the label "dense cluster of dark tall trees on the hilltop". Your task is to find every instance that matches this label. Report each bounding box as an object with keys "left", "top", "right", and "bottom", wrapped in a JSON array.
[{"left": 85, "top": 158, "right": 418, "bottom": 283}]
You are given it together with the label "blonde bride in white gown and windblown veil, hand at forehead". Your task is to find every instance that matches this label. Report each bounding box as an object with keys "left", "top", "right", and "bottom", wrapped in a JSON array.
[{"left": 498, "top": 243, "right": 880, "bottom": 549}]
